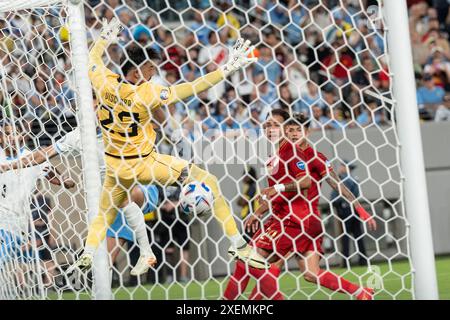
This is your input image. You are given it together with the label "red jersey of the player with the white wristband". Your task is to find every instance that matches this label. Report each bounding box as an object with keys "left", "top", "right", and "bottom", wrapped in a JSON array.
[{"left": 267, "top": 141, "right": 309, "bottom": 223}]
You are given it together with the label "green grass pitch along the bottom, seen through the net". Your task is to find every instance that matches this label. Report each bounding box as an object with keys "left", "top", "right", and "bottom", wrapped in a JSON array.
[{"left": 55, "top": 256, "right": 450, "bottom": 300}]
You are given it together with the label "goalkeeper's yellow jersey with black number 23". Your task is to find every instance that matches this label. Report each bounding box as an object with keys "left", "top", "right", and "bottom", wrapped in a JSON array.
[{"left": 89, "top": 40, "right": 173, "bottom": 159}]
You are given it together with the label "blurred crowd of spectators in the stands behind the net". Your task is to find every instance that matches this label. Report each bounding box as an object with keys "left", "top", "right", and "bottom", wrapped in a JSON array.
[{"left": 0, "top": 0, "right": 450, "bottom": 148}]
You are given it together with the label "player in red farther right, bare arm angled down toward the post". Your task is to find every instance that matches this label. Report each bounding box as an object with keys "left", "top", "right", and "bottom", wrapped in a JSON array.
[{"left": 247, "top": 115, "right": 376, "bottom": 300}]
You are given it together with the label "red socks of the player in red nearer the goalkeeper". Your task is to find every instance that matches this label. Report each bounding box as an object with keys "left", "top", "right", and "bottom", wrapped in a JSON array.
[{"left": 249, "top": 265, "right": 284, "bottom": 300}]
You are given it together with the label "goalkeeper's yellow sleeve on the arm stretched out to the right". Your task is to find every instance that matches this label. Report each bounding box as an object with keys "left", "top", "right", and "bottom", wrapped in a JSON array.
[{"left": 137, "top": 69, "right": 224, "bottom": 110}]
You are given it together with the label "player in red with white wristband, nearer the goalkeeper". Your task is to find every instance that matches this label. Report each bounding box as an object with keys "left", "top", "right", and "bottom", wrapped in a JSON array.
[{"left": 224, "top": 109, "right": 311, "bottom": 300}]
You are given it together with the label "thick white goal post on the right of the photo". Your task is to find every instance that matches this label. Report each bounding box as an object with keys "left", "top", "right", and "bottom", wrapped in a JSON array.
[{"left": 384, "top": 0, "right": 439, "bottom": 300}]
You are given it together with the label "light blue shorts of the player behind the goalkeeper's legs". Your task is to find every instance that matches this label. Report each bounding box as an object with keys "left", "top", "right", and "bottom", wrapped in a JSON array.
[{"left": 106, "top": 185, "right": 159, "bottom": 241}]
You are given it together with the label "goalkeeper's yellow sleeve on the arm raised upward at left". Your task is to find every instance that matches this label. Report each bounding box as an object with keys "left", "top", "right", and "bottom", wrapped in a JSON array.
[{"left": 89, "top": 38, "right": 118, "bottom": 90}]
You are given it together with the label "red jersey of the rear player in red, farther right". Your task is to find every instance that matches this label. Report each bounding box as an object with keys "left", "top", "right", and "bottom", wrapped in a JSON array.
[{"left": 298, "top": 145, "right": 333, "bottom": 216}]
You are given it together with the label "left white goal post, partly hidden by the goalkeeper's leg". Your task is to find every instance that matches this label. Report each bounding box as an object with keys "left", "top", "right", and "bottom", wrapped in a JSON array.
[{"left": 68, "top": 0, "right": 112, "bottom": 300}]
